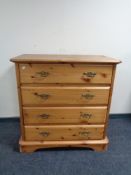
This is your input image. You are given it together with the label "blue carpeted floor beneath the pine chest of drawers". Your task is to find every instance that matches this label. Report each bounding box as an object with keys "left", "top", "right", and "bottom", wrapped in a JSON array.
[{"left": 0, "top": 117, "right": 131, "bottom": 175}]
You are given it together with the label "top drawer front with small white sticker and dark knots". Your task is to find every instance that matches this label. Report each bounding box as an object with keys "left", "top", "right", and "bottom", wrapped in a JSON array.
[{"left": 19, "top": 64, "right": 112, "bottom": 84}]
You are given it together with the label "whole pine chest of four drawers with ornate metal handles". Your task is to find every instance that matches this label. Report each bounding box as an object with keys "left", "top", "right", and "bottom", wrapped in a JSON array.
[{"left": 11, "top": 54, "right": 120, "bottom": 152}]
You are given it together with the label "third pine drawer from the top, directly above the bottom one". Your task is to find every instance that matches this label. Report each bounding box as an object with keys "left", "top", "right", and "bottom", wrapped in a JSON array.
[{"left": 23, "top": 107, "right": 107, "bottom": 125}]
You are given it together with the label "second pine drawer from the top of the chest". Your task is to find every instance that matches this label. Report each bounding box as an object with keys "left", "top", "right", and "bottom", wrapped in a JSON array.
[{"left": 21, "top": 86, "right": 110, "bottom": 106}]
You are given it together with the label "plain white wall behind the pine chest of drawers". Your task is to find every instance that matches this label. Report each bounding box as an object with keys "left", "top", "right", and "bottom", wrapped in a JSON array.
[{"left": 0, "top": 0, "right": 131, "bottom": 117}]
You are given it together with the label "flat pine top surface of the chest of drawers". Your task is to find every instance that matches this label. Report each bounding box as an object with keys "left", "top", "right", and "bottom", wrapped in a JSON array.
[{"left": 10, "top": 54, "right": 121, "bottom": 64}]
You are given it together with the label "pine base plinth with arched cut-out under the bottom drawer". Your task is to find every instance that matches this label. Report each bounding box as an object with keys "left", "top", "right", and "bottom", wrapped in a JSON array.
[{"left": 19, "top": 137, "right": 109, "bottom": 153}]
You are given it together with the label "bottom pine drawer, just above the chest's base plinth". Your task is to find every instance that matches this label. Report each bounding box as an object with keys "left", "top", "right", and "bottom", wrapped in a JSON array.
[{"left": 25, "top": 125, "right": 104, "bottom": 141}]
